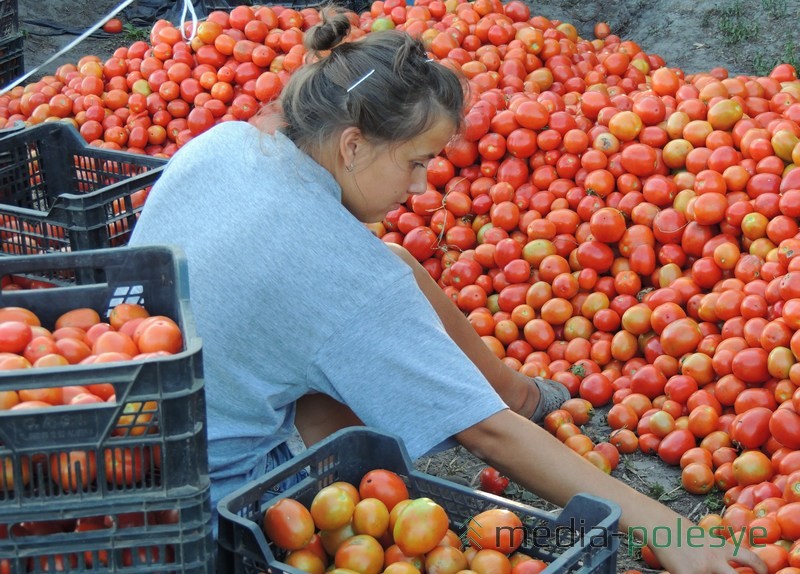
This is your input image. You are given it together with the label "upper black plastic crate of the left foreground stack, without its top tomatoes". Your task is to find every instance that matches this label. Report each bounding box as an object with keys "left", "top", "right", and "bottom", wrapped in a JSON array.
[{"left": 0, "top": 246, "right": 210, "bottom": 510}]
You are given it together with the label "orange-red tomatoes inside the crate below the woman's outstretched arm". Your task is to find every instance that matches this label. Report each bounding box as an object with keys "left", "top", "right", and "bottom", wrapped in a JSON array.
[{"left": 262, "top": 469, "right": 547, "bottom": 574}]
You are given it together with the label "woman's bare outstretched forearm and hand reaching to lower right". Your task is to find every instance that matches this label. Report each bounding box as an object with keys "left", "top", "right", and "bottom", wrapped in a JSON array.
[{"left": 456, "top": 410, "right": 767, "bottom": 574}]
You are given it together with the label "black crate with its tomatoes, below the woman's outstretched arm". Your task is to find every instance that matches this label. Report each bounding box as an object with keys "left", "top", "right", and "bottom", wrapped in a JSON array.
[{"left": 218, "top": 428, "right": 620, "bottom": 574}]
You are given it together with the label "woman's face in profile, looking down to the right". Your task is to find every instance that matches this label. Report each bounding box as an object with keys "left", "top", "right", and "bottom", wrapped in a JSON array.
[{"left": 337, "top": 119, "right": 455, "bottom": 223}]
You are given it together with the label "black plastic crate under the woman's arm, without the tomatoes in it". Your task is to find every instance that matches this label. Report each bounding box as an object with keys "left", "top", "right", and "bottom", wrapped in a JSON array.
[{"left": 217, "top": 427, "right": 620, "bottom": 574}]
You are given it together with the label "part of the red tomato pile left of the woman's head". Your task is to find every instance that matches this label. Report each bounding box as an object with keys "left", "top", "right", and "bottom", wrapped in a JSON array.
[{"left": 0, "top": 6, "right": 369, "bottom": 157}]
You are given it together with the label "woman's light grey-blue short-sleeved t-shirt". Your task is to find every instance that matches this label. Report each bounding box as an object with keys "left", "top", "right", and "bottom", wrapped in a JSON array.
[{"left": 130, "top": 122, "right": 506, "bottom": 510}]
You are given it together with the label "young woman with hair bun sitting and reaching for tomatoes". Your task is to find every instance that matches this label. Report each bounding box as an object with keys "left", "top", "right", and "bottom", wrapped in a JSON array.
[{"left": 131, "top": 9, "right": 766, "bottom": 574}]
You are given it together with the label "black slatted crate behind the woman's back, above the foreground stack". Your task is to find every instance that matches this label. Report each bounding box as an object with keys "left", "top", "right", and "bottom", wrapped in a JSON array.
[{"left": 0, "top": 122, "right": 166, "bottom": 255}]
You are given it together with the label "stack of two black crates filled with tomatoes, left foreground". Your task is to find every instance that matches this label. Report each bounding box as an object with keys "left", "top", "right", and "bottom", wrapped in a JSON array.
[{"left": 0, "top": 246, "right": 214, "bottom": 574}]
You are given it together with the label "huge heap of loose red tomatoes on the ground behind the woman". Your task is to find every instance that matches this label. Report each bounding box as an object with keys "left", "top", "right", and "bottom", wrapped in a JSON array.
[{"left": 0, "top": 0, "right": 800, "bottom": 571}]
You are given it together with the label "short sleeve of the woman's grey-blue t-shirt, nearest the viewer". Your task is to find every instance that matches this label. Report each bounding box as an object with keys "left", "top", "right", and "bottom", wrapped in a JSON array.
[{"left": 309, "top": 270, "right": 507, "bottom": 458}]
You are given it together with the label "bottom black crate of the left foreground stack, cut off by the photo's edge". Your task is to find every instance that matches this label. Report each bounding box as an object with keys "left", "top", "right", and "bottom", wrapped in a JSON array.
[{"left": 0, "top": 489, "right": 215, "bottom": 574}]
